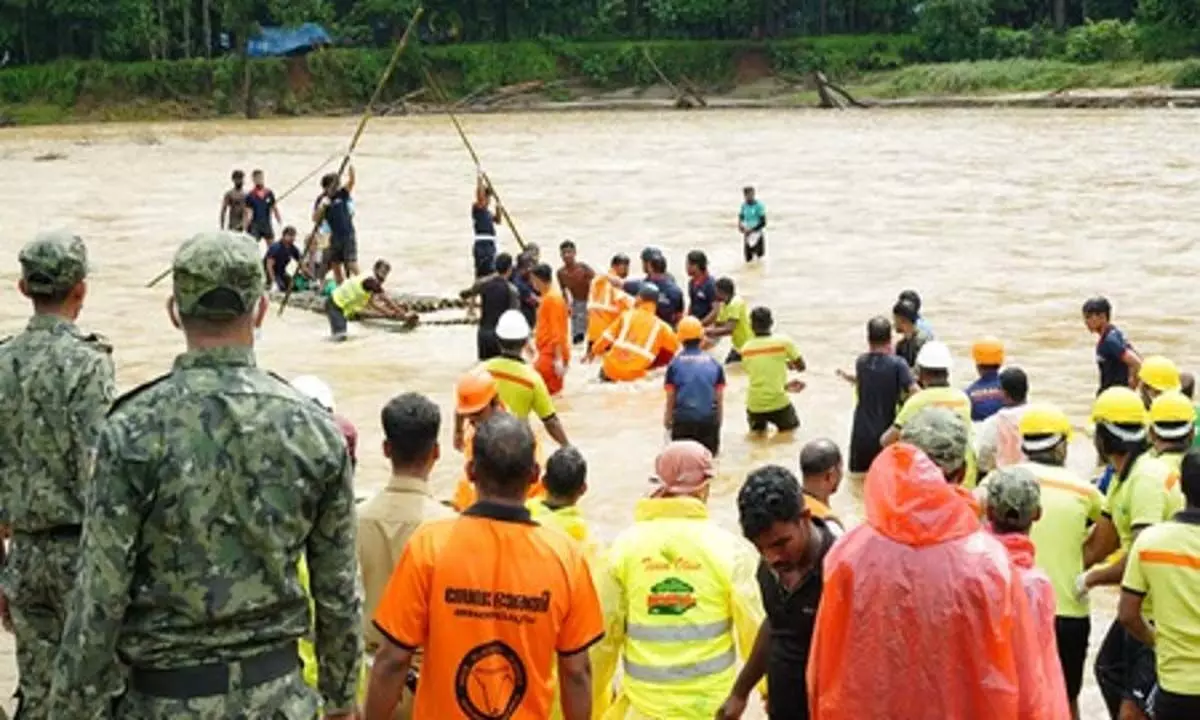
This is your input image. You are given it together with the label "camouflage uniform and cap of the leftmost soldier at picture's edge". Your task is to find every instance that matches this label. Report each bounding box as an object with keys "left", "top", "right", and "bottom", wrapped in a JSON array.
[{"left": 0, "top": 233, "right": 114, "bottom": 720}]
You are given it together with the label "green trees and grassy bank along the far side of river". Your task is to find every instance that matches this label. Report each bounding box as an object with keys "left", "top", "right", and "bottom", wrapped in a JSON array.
[{"left": 0, "top": 0, "right": 1200, "bottom": 122}]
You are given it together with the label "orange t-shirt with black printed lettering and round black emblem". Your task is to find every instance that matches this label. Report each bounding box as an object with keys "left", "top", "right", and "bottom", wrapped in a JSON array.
[{"left": 374, "top": 502, "right": 604, "bottom": 720}]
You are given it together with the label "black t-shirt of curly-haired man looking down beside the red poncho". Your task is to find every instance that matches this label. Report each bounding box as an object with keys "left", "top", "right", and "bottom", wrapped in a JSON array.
[{"left": 758, "top": 517, "right": 834, "bottom": 720}]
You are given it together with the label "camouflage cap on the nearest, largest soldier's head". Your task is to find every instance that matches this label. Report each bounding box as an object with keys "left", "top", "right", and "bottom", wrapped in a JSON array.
[{"left": 172, "top": 232, "right": 264, "bottom": 319}]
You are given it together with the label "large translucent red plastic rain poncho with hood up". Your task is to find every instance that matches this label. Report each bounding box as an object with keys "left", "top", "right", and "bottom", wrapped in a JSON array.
[{"left": 808, "top": 443, "right": 1052, "bottom": 720}]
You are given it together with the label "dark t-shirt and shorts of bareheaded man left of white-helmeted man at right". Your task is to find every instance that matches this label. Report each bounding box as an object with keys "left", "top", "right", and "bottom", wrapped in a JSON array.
[{"left": 850, "top": 353, "right": 912, "bottom": 473}]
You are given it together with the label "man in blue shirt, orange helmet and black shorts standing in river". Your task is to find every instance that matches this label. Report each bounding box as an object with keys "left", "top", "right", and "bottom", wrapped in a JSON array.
[{"left": 662, "top": 317, "right": 725, "bottom": 457}]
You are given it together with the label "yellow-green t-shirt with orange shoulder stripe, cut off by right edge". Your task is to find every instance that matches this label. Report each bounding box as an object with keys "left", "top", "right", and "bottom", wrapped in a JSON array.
[{"left": 1121, "top": 518, "right": 1200, "bottom": 695}]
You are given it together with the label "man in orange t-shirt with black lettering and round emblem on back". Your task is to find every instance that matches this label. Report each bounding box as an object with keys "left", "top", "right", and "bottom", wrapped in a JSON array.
[{"left": 365, "top": 413, "right": 604, "bottom": 720}]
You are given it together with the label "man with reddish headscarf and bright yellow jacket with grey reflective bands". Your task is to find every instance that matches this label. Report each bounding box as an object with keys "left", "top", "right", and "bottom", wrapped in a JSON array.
[{"left": 593, "top": 440, "right": 763, "bottom": 720}]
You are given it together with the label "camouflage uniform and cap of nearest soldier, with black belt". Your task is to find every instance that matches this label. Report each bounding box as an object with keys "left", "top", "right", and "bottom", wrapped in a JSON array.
[{"left": 50, "top": 233, "right": 362, "bottom": 720}]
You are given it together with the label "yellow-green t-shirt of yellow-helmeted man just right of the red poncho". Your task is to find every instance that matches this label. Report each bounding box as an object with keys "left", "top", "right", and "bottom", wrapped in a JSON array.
[{"left": 1022, "top": 462, "right": 1104, "bottom": 618}]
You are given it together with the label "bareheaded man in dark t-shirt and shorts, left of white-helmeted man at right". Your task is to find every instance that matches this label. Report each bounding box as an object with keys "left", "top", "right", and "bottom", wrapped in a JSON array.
[{"left": 838, "top": 316, "right": 918, "bottom": 480}]
